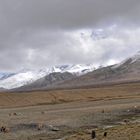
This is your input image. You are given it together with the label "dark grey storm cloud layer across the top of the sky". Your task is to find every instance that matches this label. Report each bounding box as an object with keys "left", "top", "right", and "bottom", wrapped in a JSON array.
[{"left": 0, "top": 0, "right": 140, "bottom": 30}]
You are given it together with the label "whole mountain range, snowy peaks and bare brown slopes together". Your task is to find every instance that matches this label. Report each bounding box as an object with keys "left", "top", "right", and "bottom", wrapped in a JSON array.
[{"left": 0, "top": 52, "right": 140, "bottom": 90}]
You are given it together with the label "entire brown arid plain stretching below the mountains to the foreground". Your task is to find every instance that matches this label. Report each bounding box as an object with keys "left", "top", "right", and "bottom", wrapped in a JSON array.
[{"left": 0, "top": 83, "right": 140, "bottom": 140}]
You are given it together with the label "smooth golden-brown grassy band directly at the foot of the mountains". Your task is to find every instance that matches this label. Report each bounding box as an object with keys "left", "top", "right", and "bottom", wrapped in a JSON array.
[{"left": 0, "top": 83, "right": 140, "bottom": 108}]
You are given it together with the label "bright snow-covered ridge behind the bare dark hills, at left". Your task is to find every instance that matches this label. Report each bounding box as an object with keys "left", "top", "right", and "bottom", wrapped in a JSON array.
[{"left": 0, "top": 64, "right": 95, "bottom": 89}]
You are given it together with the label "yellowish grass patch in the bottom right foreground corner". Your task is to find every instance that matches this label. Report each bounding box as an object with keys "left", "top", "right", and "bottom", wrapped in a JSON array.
[{"left": 61, "top": 124, "right": 140, "bottom": 140}]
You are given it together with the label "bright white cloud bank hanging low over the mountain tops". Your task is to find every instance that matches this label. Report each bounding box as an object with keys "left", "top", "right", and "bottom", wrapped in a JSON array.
[{"left": 0, "top": 25, "right": 140, "bottom": 70}]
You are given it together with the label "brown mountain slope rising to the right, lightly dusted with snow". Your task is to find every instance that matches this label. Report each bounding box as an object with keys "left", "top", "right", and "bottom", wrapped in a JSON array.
[{"left": 44, "top": 52, "right": 140, "bottom": 88}]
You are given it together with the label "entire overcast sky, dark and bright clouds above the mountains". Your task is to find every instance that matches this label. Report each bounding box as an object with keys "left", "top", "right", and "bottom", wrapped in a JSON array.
[{"left": 0, "top": 0, "right": 140, "bottom": 72}]
